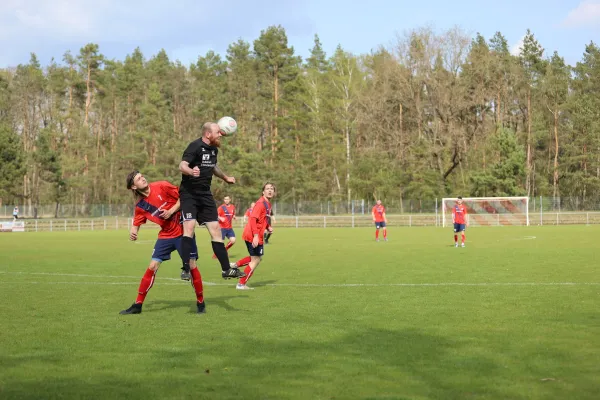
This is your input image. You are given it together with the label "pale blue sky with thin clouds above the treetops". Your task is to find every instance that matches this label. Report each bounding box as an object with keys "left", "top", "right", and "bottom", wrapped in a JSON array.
[{"left": 0, "top": 0, "right": 600, "bottom": 67}]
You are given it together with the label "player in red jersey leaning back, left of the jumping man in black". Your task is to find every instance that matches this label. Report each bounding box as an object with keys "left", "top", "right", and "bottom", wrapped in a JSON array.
[{"left": 120, "top": 171, "right": 206, "bottom": 314}]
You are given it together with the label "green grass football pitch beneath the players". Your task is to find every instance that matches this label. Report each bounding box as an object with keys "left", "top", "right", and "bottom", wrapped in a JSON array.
[{"left": 0, "top": 226, "right": 600, "bottom": 400}]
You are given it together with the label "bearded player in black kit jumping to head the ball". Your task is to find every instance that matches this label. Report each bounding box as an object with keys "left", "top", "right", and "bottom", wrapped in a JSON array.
[{"left": 179, "top": 122, "right": 246, "bottom": 279}]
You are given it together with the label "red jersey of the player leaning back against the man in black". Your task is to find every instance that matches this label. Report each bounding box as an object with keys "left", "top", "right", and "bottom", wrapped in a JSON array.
[{"left": 133, "top": 181, "right": 183, "bottom": 239}]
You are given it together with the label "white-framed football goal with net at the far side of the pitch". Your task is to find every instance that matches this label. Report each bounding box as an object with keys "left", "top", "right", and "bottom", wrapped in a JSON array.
[{"left": 442, "top": 197, "right": 529, "bottom": 226}]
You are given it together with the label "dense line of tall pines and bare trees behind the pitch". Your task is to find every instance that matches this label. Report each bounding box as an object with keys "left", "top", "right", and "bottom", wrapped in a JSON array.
[{"left": 0, "top": 26, "right": 600, "bottom": 216}]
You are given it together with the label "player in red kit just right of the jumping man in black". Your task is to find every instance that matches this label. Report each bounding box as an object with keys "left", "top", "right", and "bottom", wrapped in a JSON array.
[{"left": 231, "top": 182, "right": 275, "bottom": 290}]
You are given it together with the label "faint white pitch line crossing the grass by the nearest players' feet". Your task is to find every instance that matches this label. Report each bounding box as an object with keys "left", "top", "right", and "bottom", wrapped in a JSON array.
[{"left": 0, "top": 271, "right": 600, "bottom": 288}]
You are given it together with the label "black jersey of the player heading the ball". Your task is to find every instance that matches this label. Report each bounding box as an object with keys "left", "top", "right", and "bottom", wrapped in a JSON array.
[{"left": 181, "top": 139, "right": 219, "bottom": 194}]
